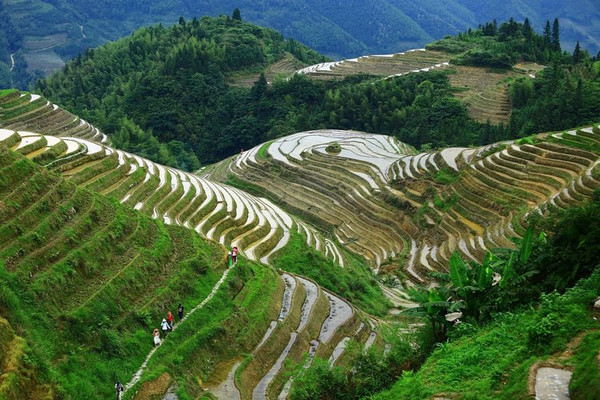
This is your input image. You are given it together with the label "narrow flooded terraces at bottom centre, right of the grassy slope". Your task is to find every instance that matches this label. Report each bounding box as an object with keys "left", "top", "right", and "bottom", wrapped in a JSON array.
[{"left": 205, "top": 274, "right": 383, "bottom": 400}]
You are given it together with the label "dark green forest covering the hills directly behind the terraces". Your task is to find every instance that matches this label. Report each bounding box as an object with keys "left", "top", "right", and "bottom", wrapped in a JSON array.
[{"left": 37, "top": 17, "right": 600, "bottom": 170}]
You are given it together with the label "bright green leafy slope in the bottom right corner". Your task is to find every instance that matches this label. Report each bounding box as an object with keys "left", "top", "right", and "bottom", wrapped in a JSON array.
[{"left": 373, "top": 269, "right": 600, "bottom": 399}]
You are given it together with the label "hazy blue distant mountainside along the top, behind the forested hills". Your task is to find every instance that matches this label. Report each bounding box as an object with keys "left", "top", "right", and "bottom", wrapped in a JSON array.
[{"left": 0, "top": 0, "right": 600, "bottom": 86}]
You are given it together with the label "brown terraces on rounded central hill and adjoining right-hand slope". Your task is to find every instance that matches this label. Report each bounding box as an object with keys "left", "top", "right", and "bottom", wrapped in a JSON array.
[{"left": 207, "top": 127, "right": 600, "bottom": 296}]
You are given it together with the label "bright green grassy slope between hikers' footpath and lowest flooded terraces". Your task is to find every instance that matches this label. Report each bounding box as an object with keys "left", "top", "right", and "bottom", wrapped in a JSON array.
[{"left": 132, "top": 260, "right": 278, "bottom": 399}]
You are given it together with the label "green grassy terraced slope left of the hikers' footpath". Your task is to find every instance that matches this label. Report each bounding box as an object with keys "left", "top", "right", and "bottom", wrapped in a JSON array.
[{"left": 0, "top": 147, "right": 229, "bottom": 398}]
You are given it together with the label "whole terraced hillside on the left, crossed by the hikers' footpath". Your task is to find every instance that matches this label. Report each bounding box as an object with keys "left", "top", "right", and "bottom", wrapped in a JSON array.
[{"left": 0, "top": 102, "right": 400, "bottom": 398}]
